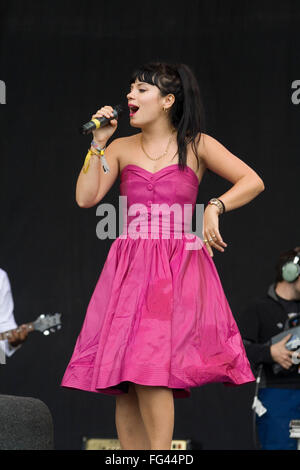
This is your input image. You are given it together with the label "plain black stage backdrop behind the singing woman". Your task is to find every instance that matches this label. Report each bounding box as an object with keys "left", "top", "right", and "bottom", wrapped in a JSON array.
[{"left": 0, "top": 0, "right": 300, "bottom": 450}]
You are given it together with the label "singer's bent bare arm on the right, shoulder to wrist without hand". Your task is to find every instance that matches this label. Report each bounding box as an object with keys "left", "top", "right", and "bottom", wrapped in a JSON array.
[{"left": 198, "top": 134, "right": 265, "bottom": 212}]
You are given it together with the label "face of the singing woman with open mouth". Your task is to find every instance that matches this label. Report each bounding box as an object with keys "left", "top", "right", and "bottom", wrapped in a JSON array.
[{"left": 127, "top": 80, "right": 165, "bottom": 127}]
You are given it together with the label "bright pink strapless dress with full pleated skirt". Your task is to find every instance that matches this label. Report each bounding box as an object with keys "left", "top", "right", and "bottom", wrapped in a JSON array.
[{"left": 61, "top": 164, "right": 255, "bottom": 398}]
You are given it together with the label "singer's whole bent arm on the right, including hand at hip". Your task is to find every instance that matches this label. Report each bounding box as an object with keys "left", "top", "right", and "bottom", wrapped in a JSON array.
[{"left": 198, "top": 133, "right": 265, "bottom": 256}]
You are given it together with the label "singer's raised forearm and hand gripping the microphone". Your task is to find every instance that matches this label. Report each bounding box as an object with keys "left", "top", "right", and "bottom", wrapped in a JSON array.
[{"left": 76, "top": 106, "right": 121, "bottom": 208}]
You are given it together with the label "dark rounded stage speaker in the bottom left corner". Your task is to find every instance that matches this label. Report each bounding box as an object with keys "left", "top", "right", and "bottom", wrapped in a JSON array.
[{"left": 0, "top": 395, "right": 54, "bottom": 450}]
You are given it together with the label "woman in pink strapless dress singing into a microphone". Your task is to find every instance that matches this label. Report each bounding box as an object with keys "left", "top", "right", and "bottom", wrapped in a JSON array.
[{"left": 61, "top": 62, "right": 265, "bottom": 450}]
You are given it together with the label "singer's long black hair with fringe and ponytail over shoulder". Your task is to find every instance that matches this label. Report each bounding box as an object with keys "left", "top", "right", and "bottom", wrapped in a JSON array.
[{"left": 130, "top": 62, "right": 205, "bottom": 173}]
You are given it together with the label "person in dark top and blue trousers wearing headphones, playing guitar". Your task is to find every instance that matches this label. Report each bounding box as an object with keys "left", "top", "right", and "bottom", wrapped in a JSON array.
[{"left": 237, "top": 246, "right": 300, "bottom": 450}]
